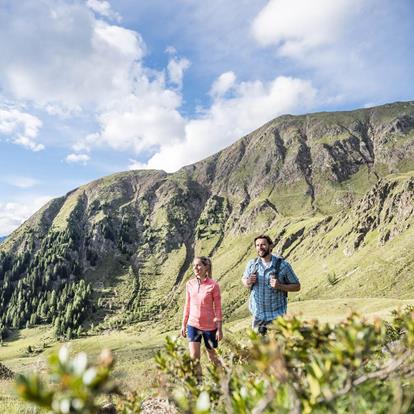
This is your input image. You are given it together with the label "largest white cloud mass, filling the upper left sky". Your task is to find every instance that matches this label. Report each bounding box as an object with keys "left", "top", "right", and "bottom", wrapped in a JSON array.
[{"left": 0, "top": 0, "right": 194, "bottom": 162}]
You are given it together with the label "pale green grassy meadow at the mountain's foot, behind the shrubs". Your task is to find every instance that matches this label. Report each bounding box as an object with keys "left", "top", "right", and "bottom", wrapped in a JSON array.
[{"left": 0, "top": 298, "right": 414, "bottom": 414}]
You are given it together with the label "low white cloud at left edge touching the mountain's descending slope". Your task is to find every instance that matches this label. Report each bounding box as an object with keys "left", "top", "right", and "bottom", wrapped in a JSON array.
[{"left": 0, "top": 195, "right": 51, "bottom": 236}]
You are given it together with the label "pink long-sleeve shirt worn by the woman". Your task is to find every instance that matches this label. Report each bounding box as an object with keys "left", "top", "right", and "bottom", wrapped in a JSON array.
[{"left": 183, "top": 277, "right": 222, "bottom": 331}]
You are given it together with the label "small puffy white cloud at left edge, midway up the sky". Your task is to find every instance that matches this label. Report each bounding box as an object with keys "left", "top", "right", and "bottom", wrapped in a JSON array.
[{"left": 0, "top": 107, "right": 44, "bottom": 151}]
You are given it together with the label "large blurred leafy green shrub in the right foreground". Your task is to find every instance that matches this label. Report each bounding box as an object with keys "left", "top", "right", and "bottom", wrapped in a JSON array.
[{"left": 156, "top": 308, "right": 414, "bottom": 414}]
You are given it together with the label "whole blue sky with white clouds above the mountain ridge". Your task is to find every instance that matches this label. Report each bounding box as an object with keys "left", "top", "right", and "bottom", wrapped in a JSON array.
[{"left": 0, "top": 0, "right": 414, "bottom": 236}]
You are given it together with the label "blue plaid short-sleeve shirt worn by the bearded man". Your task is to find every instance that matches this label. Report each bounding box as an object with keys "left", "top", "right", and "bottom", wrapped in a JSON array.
[{"left": 243, "top": 255, "right": 299, "bottom": 321}]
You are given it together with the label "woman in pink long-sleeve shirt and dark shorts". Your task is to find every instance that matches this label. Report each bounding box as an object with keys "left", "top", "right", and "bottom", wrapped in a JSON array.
[{"left": 181, "top": 256, "right": 223, "bottom": 380}]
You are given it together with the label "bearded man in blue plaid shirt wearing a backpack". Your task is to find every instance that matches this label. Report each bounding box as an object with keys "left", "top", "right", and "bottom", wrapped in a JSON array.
[{"left": 242, "top": 235, "right": 300, "bottom": 335}]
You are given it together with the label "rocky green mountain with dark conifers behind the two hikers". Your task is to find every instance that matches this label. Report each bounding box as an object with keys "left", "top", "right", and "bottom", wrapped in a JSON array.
[{"left": 0, "top": 102, "right": 414, "bottom": 337}]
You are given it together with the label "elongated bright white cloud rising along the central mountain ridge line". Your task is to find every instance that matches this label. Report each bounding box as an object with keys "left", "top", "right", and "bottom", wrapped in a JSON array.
[{"left": 142, "top": 76, "right": 316, "bottom": 171}]
